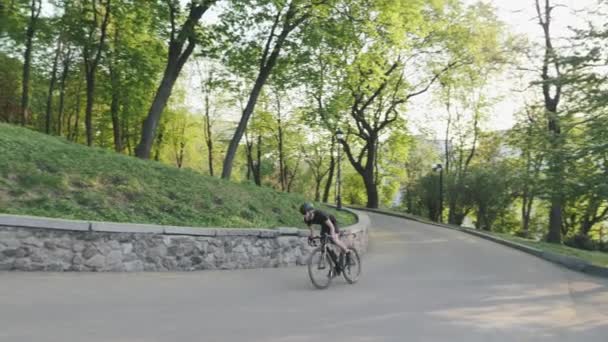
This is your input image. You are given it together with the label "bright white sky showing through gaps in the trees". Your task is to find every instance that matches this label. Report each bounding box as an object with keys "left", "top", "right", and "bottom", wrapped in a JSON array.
[{"left": 183, "top": 0, "right": 598, "bottom": 138}]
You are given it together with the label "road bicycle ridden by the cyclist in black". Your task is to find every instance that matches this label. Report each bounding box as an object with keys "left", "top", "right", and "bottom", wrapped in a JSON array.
[{"left": 308, "top": 234, "right": 361, "bottom": 289}]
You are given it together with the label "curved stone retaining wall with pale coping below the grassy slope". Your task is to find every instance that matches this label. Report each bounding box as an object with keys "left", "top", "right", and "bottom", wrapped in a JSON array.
[{"left": 0, "top": 212, "right": 369, "bottom": 272}]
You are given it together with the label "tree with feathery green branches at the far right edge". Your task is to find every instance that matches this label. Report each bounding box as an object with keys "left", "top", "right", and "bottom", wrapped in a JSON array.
[{"left": 556, "top": 1, "right": 608, "bottom": 244}]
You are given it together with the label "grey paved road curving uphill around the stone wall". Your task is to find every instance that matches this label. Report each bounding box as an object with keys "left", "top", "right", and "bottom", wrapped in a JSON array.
[{"left": 0, "top": 214, "right": 608, "bottom": 342}]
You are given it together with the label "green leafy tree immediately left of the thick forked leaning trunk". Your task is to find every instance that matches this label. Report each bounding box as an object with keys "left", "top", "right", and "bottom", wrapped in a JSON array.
[{"left": 101, "top": 2, "right": 165, "bottom": 152}]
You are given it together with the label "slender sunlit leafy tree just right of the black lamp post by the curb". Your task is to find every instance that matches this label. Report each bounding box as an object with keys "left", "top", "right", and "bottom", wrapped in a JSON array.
[{"left": 438, "top": 4, "right": 513, "bottom": 225}]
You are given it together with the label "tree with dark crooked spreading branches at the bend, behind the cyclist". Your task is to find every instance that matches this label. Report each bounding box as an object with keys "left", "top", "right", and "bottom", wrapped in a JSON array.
[{"left": 314, "top": 1, "right": 441, "bottom": 208}]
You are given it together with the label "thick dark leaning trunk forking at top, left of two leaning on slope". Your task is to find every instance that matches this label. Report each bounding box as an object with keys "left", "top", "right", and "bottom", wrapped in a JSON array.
[{"left": 135, "top": 0, "right": 216, "bottom": 159}]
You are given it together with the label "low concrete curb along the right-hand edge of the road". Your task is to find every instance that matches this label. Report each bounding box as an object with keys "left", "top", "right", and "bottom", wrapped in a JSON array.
[{"left": 356, "top": 207, "right": 608, "bottom": 278}]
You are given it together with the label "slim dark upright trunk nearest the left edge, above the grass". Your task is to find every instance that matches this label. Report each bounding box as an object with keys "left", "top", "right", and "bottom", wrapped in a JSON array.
[{"left": 21, "top": 0, "right": 42, "bottom": 126}]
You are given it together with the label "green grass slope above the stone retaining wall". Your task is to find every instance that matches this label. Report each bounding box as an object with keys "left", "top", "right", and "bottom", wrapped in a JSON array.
[{"left": 0, "top": 124, "right": 356, "bottom": 228}]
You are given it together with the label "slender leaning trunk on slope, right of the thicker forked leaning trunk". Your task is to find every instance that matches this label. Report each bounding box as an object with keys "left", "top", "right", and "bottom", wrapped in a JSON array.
[{"left": 222, "top": 1, "right": 307, "bottom": 179}]
